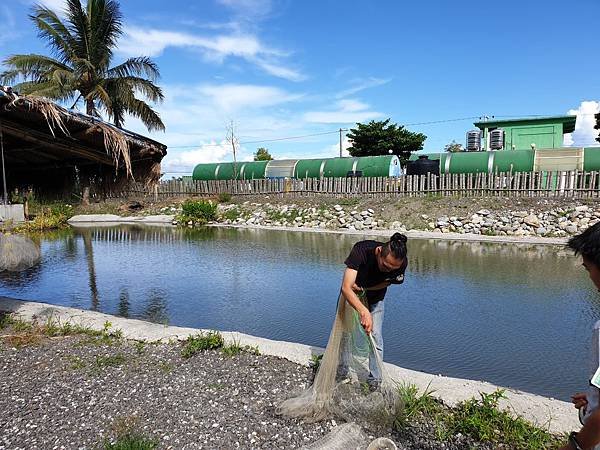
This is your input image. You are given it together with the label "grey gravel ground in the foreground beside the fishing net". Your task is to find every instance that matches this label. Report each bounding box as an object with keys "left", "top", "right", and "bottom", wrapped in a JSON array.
[{"left": 0, "top": 329, "right": 496, "bottom": 450}]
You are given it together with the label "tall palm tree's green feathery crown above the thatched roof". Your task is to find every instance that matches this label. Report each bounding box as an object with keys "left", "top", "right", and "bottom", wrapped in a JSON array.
[{"left": 0, "top": 0, "right": 165, "bottom": 131}]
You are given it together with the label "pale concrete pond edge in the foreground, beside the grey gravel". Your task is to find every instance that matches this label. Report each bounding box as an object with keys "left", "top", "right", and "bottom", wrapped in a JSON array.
[{"left": 0, "top": 297, "right": 579, "bottom": 433}]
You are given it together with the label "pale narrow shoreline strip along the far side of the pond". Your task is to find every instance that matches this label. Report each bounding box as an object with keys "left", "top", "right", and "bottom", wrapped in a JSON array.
[{"left": 68, "top": 214, "right": 568, "bottom": 245}]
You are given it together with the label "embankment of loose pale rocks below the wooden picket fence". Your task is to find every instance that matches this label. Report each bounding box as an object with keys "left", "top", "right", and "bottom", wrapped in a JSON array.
[{"left": 199, "top": 202, "right": 600, "bottom": 237}]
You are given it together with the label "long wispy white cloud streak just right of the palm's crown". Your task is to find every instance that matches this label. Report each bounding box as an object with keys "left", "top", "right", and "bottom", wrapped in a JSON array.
[{"left": 117, "top": 26, "right": 305, "bottom": 81}]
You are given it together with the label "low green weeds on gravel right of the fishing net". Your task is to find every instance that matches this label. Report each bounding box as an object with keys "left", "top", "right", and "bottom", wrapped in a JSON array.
[{"left": 394, "top": 384, "right": 560, "bottom": 450}]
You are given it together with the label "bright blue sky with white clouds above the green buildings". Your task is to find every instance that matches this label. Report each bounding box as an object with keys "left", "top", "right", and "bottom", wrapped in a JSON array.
[{"left": 0, "top": 0, "right": 600, "bottom": 176}]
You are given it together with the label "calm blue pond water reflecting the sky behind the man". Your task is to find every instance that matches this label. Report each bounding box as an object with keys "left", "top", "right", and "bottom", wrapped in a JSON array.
[{"left": 0, "top": 226, "right": 600, "bottom": 400}]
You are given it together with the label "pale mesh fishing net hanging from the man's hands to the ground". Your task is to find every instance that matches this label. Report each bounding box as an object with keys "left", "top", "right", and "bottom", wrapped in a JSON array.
[{"left": 277, "top": 293, "right": 401, "bottom": 432}]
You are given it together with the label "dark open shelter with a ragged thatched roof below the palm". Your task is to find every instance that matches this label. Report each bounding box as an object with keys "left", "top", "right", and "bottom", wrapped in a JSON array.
[{"left": 0, "top": 87, "right": 167, "bottom": 181}]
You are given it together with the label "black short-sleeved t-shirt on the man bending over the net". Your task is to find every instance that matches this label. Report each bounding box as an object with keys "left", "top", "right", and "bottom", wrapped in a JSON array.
[{"left": 344, "top": 241, "right": 408, "bottom": 304}]
